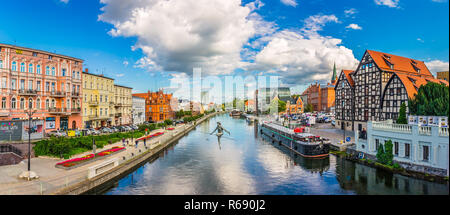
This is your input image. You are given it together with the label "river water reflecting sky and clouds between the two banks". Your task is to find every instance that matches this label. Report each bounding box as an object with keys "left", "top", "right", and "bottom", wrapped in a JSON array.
[{"left": 104, "top": 114, "right": 449, "bottom": 195}]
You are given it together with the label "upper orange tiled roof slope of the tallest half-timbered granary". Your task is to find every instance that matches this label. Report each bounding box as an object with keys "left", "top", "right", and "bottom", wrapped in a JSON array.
[{"left": 367, "top": 50, "right": 433, "bottom": 76}]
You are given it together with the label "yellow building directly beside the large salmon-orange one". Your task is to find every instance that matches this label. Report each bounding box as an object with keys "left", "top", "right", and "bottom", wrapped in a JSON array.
[{"left": 83, "top": 69, "right": 115, "bottom": 128}]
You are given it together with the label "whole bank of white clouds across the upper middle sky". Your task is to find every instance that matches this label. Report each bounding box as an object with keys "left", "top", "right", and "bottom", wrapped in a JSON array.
[{"left": 98, "top": 0, "right": 360, "bottom": 84}]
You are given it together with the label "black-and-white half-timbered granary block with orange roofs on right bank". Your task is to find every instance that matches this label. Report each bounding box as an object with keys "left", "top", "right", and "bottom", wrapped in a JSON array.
[{"left": 335, "top": 50, "right": 448, "bottom": 130}]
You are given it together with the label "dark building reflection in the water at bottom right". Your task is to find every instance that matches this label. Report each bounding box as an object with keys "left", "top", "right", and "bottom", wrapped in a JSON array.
[{"left": 336, "top": 158, "right": 448, "bottom": 195}]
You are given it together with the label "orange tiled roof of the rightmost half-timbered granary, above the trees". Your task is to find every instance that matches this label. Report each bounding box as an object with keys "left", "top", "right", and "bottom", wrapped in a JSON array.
[{"left": 391, "top": 72, "right": 448, "bottom": 99}]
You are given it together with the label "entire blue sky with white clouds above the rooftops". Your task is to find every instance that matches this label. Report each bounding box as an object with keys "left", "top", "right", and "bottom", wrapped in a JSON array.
[{"left": 0, "top": 0, "right": 449, "bottom": 98}]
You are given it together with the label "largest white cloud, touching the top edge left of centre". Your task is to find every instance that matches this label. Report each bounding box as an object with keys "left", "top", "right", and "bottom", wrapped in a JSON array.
[{"left": 99, "top": 0, "right": 264, "bottom": 74}]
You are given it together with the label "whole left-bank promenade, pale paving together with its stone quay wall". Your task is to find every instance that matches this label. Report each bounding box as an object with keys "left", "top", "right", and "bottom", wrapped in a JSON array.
[{"left": 0, "top": 112, "right": 223, "bottom": 195}]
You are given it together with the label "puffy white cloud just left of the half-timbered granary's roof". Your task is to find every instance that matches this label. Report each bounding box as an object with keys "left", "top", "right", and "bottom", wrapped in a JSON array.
[{"left": 252, "top": 15, "right": 358, "bottom": 85}]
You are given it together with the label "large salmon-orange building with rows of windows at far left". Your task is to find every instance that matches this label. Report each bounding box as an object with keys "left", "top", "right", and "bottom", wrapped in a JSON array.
[{"left": 0, "top": 44, "right": 83, "bottom": 132}]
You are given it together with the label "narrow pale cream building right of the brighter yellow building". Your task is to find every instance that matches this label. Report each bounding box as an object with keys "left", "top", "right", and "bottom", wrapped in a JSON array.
[{"left": 113, "top": 84, "right": 133, "bottom": 125}]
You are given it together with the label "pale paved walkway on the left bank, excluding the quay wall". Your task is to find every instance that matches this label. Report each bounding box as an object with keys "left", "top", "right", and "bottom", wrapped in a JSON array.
[{"left": 0, "top": 122, "right": 185, "bottom": 195}]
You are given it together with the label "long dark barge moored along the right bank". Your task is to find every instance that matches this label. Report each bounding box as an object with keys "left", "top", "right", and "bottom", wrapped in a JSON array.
[{"left": 261, "top": 122, "right": 331, "bottom": 158}]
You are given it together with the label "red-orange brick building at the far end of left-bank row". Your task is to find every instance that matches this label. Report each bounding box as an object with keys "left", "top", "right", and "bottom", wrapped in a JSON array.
[{"left": 133, "top": 90, "right": 176, "bottom": 122}]
